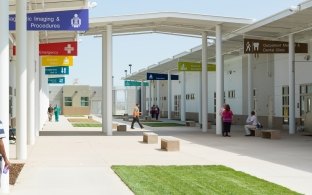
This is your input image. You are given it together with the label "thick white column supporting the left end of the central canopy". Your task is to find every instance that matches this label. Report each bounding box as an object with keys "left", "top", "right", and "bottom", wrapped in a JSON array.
[{"left": 102, "top": 25, "right": 113, "bottom": 135}]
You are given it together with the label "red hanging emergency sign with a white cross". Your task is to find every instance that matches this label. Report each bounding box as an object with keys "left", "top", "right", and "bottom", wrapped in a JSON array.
[{"left": 39, "top": 41, "right": 78, "bottom": 56}]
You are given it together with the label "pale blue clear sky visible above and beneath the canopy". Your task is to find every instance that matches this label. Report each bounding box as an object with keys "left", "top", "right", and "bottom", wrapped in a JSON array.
[{"left": 66, "top": 0, "right": 303, "bottom": 86}]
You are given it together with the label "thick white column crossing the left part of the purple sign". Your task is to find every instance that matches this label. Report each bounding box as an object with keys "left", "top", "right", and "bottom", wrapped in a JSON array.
[{"left": 16, "top": 0, "right": 27, "bottom": 160}]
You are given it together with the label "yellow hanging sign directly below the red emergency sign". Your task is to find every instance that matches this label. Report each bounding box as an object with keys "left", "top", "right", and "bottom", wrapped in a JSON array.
[{"left": 41, "top": 56, "right": 74, "bottom": 66}]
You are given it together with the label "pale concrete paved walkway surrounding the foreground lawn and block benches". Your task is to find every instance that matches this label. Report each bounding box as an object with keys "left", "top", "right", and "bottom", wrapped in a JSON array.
[{"left": 10, "top": 116, "right": 312, "bottom": 195}]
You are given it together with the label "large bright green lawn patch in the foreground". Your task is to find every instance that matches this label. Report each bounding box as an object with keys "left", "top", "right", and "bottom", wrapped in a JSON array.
[{"left": 112, "top": 165, "right": 298, "bottom": 195}]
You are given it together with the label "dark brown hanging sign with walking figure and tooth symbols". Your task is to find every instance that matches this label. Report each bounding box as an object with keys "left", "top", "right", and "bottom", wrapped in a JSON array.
[{"left": 244, "top": 39, "right": 308, "bottom": 54}]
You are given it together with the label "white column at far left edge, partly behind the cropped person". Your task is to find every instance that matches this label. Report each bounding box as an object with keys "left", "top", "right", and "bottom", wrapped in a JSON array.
[{"left": 0, "top": 1, "right": 10, "bottom": 194}]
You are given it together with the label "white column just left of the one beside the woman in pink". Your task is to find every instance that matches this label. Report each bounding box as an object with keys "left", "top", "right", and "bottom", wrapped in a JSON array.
[{"left": 201, "top": 32, "right": 208, "bottom": 132}]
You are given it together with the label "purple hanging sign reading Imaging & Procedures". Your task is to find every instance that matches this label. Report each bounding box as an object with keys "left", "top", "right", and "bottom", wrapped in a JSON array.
[{"left": 9, "top": 9, "right": 89, "bottom": 31}]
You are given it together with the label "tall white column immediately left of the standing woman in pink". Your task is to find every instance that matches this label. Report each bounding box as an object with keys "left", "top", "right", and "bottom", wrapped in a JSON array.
[{"left": 216, "top": 25, "right": 224, "bottom": 135}]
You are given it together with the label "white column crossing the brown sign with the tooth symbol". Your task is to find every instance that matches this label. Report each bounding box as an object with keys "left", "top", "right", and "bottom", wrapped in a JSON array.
[{"left": 288, "top": 34, "right": 296, "bottom": 134}]
